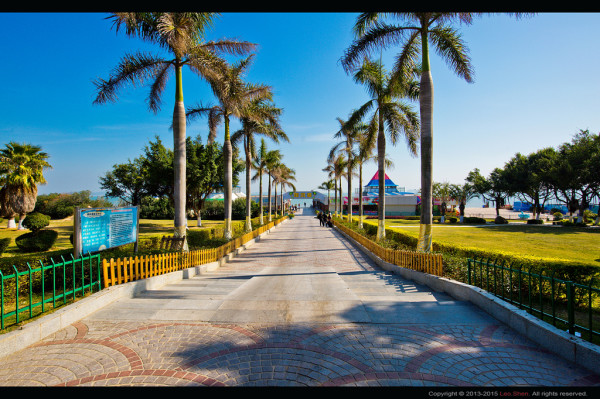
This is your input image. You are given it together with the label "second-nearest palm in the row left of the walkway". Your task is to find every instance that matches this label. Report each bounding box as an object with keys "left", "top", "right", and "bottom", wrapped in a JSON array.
[{"left": 187, "top": 55, "right": 271, "bottom": 240}]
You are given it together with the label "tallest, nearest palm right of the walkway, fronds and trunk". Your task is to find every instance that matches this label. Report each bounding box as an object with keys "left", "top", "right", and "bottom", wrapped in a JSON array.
[{"left": 342, "top": 12, "right": 523, "bottom": 252}]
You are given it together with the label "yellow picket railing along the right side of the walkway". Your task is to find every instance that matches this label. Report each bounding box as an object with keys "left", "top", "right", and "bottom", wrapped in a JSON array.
[{"left": 335, "top": 219, "right": 443, "bottom": 277}]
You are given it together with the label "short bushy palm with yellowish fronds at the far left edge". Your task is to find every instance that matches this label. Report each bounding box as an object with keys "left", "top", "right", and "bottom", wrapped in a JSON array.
[{"left": 0, "top": 142, "right": 51, "bottom": 230}]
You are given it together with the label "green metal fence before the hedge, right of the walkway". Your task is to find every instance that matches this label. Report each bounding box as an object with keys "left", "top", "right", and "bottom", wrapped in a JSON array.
[{"left": 468, "top": 259, "right": 600, "bottom": 342}]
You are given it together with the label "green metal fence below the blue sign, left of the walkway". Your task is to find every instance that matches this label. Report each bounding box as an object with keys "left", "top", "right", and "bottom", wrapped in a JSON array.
[{"left": 0, "top": 254, "right": 102, "bottom": 329}]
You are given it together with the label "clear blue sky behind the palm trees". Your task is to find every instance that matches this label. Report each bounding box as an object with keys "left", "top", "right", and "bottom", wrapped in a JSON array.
[{"left": 0, "top": 12, "right": 600, "bottom": 205}]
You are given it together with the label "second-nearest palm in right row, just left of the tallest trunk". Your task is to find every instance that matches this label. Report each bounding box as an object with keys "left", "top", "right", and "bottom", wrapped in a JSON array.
[{"left": 340, "top": 59, "right": 419, "bottom": 241}]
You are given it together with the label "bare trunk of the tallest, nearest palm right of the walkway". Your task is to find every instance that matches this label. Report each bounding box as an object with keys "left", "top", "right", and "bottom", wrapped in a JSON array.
[{"left": 417, "top": 33, "right": 433, "bottom": 252}]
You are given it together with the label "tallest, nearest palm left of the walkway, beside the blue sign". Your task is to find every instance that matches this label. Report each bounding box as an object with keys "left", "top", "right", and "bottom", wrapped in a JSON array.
[{"left": 94, "top": 12, "right": 255, "bottom": 250}]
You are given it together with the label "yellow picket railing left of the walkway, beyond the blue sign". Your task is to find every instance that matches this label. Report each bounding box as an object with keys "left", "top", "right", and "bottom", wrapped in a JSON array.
[{"left": 102, "top": 216, "right": 287, "bottom": 288}]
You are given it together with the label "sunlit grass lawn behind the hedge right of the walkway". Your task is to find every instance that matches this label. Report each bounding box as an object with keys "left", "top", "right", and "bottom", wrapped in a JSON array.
[{"left": 365, "top": 219, "right": 600, "bottom": 266}]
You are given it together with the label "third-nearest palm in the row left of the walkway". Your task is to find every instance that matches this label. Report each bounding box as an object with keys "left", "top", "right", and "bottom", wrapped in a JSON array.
[{"left": 231, "top": 98, "right": 290, "bottom": 232}]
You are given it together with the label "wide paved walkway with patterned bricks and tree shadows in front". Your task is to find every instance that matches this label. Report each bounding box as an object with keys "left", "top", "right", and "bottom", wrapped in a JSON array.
[{"left": 0, "top": 210, "right": 600, "bottom": 387}]
